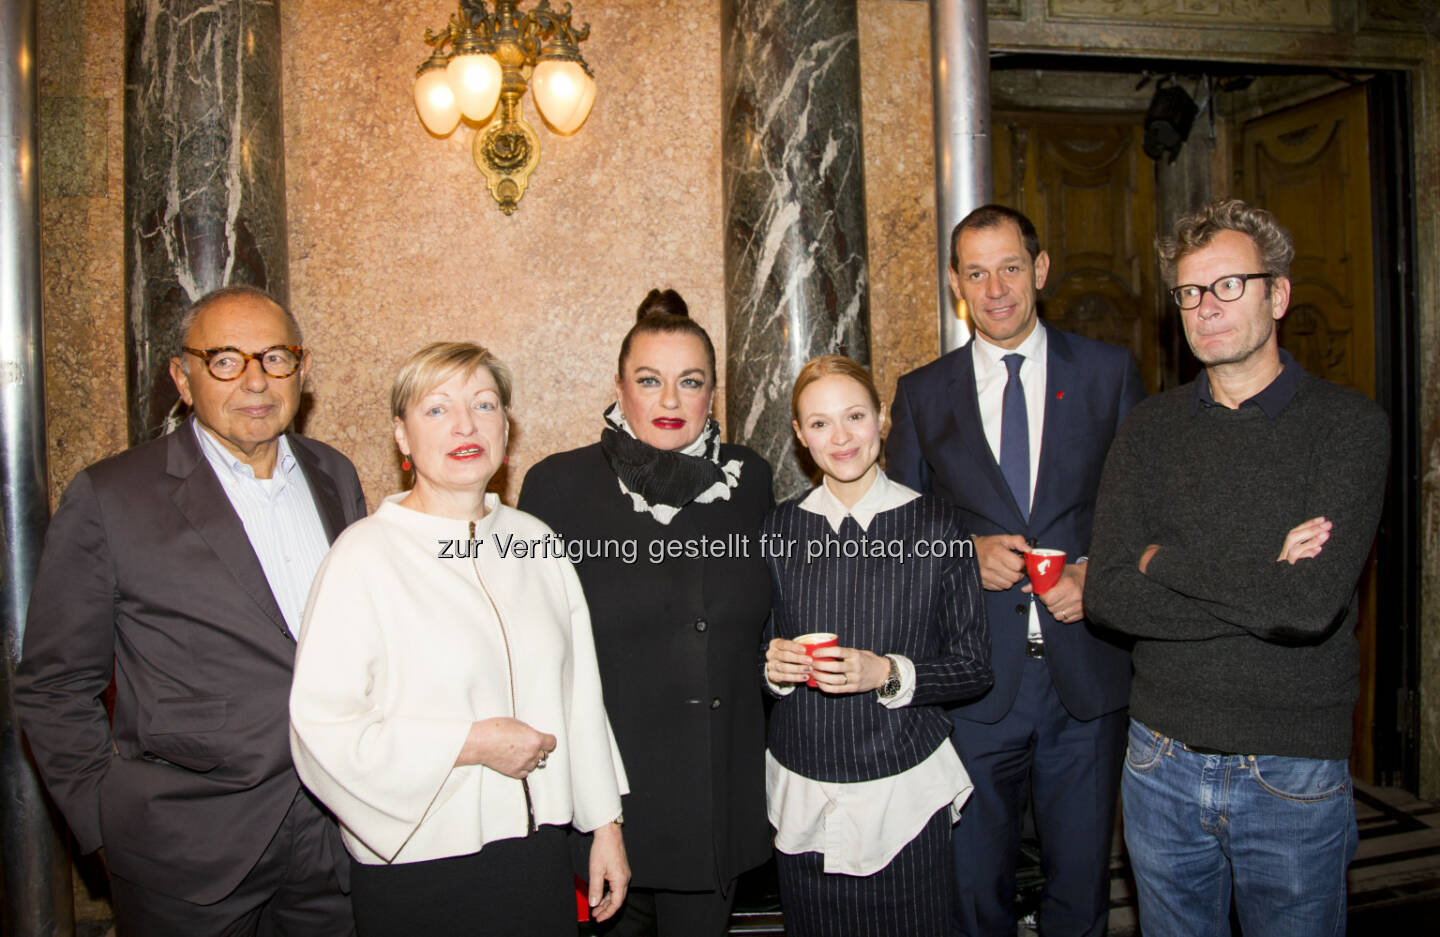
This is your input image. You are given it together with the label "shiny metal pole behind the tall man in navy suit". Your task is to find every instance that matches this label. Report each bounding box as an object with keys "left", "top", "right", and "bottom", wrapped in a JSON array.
[{"left": 930, "top": 0, "right": 995, "bottom": 354}]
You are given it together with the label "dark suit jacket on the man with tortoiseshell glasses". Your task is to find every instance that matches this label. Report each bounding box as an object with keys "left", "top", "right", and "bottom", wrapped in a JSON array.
[{"left": 16, "top": 425, "right": 366, "bottom": 904}]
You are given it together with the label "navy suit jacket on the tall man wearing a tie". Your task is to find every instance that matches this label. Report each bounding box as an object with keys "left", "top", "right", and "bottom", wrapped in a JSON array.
[{"left": 886, "top": 322, "right": 1145, "bottom": 723}]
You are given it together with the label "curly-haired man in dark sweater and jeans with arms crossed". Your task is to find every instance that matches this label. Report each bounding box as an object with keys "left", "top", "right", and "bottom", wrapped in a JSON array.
[{"left": 1086, "top": 199, "right": 1388, "bottom": 937}]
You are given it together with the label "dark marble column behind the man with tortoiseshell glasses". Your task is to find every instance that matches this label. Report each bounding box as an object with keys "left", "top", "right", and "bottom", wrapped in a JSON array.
[{"left": 125, "top": 0, "right": 289, "bottom": 443}]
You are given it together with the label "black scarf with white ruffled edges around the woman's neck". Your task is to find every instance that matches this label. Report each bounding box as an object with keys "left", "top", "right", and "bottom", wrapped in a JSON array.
[{"left": 600, "top": 403, "right": 740, "bottom": 524}]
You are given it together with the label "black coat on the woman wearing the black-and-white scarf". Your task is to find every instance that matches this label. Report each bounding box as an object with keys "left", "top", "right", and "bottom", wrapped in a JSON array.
[{"left": 518, "top": 445, "right": 772, "bottom": 891}]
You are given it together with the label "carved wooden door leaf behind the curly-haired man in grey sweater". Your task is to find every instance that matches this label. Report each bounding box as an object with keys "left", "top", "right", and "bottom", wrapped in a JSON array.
[{"left": 1237, "top": 88, "right": 1378, "bottom": 782}]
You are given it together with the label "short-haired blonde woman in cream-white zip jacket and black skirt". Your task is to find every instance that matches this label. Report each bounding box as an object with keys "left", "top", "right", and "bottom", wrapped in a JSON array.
[{"left": 291, "top": 343, "right": 629, "bottom": 937}]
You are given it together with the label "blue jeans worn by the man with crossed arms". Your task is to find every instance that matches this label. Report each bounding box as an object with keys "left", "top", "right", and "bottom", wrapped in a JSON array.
[{"left": 1120, "top": 718, "right": 1359, "bottom": 937}]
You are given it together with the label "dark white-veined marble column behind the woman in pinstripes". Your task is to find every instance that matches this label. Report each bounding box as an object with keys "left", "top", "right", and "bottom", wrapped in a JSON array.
[{"left": 721, "top": 0, "right": 870, "bottom": 498}]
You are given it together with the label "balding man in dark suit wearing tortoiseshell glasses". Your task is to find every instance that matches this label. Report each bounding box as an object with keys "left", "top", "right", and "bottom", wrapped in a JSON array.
[{"left": 16, "top": 286, "right": 366, "bottom": 937}]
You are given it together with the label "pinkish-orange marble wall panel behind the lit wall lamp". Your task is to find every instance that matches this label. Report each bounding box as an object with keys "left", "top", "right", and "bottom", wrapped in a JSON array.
[{"left": 284, "top": 0, "right": 724, "bottom": 501}]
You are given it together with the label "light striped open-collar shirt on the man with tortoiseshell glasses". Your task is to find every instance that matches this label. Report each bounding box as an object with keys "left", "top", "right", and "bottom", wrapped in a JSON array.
[{"left": 192, "top": 420, "right": 330, "bottom": 635}]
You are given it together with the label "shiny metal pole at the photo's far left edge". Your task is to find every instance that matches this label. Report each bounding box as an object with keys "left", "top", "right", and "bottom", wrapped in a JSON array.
[{"left": 0, "top": 0, "right": 75, "bottom": 937}]
